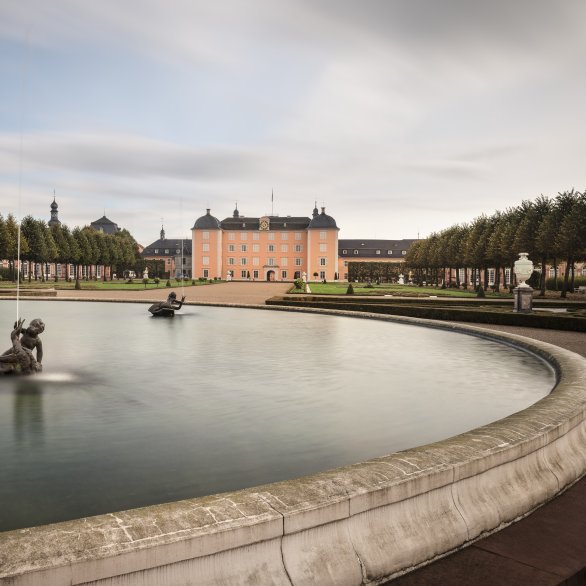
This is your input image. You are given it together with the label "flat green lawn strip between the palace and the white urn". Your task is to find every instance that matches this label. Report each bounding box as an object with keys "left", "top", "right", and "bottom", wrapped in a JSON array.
[{"left": 290, "top": 283, "right": 512, "bottom": 298}]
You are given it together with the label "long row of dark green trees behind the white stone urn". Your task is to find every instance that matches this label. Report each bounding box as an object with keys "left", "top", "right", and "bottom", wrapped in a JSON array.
[{"left": 405, "top": 189, "right": 586, "bottom": 297}]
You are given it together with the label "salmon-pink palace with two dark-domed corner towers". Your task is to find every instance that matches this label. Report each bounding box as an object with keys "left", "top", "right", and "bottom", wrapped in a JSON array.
[{"left": 192, "top": 207, "right": 339, "bottom": 281}]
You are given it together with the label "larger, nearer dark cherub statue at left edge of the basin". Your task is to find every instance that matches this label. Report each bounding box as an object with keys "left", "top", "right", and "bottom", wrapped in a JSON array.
[{"left": 0, "top": 318, "right": 45, "bottom": 374}]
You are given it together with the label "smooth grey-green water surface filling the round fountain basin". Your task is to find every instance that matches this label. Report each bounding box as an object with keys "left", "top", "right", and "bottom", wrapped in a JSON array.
[{"left": 0, "top": 301, "right": 554, "bottom": 531}]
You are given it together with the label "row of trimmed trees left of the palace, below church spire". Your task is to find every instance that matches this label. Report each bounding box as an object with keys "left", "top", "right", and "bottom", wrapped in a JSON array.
[{"left": 0, "top": 214, "right": 140, "bottom": 281}]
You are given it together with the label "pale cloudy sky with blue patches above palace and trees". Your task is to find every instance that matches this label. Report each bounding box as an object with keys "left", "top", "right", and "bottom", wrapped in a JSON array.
[{"left": 0, "top": 0, "right": 586, "bottom": 245}]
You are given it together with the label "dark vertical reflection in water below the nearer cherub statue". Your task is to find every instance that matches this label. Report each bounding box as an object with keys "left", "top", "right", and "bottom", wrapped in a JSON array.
[{"left": 14, "top": 376, "right": 45, "bottom": 447}]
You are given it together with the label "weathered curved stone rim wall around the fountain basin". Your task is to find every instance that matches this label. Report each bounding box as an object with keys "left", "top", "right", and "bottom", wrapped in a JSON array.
[{"left": 0, "top": 304, "right": 586, "bottom": 586}]
